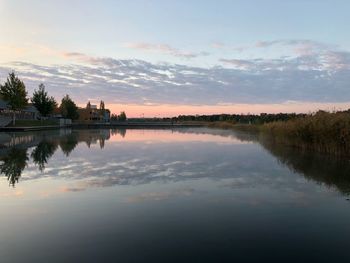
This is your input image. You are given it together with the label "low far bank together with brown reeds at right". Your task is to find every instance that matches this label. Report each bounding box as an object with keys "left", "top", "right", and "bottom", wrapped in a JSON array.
[{"left": 0, "top": 114, "right": 350, "bottom": 157}]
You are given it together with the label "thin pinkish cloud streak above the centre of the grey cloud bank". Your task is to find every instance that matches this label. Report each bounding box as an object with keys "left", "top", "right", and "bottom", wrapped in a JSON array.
[{"left": 125, "top": 42, "right": 209, "bottom": 59}]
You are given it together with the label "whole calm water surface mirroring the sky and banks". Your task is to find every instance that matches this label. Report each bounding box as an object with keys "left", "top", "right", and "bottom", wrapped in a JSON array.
[{"left": 0, "top": 128, "right": 350, "bottom": 262}]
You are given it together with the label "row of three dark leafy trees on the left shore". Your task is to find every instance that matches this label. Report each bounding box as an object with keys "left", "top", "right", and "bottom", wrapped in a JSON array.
[{"left": 0, "top": 72, "right": 79, "bottom": 123}]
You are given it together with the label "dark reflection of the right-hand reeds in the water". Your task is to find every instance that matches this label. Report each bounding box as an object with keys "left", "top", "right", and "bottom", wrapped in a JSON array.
[{"left": 180, "top": 129, "right": 350, "bottom": 195}]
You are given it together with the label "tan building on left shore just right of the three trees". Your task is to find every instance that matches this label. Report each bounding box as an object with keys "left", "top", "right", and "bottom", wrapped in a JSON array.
[{"left": 78, "top": 101, "right": 110, "bottom": 122}]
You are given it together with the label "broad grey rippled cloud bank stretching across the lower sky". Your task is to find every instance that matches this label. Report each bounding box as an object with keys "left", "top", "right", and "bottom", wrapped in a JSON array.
[{"left": 0, "top": 40, "right": 350, "bottom": 105}]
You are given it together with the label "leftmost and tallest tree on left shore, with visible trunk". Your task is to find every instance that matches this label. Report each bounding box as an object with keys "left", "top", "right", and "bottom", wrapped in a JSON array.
[{"left": 0, "top": 72, "right": 28, "bottom": 124}]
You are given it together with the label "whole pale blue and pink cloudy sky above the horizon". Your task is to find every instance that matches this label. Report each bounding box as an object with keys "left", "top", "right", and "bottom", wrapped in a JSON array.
[{"left": 0, "top": 0, "right": 350, "bottom": 117}]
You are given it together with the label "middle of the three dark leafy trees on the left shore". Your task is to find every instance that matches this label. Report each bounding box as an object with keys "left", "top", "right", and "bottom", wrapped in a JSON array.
[{"left": 31, "top": 83, "right": 57, "bottom": 117}]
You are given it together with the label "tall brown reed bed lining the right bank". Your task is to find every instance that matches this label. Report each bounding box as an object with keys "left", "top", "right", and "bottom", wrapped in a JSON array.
[{"left": 207, "top": 111, "right": 350, "bottom": 157}]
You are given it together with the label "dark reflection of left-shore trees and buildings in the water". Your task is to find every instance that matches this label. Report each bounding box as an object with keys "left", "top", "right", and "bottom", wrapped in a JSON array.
[{"left": 0, "top": 129, "right": 120, "bottom": 186}]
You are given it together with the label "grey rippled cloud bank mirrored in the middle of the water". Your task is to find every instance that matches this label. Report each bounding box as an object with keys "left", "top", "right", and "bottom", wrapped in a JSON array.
[{"left": 15, "top": 128, "right": 328, "bottom": 197}]
